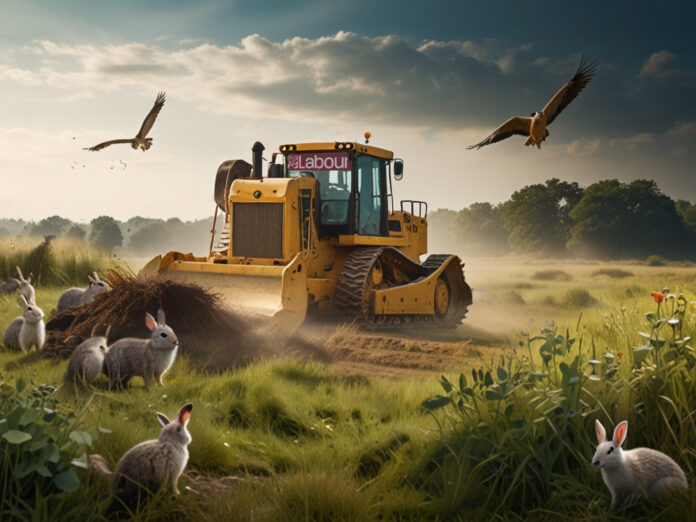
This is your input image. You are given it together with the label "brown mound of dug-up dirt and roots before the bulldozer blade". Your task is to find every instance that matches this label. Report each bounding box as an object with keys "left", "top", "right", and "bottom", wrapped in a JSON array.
[{"left": 43, "top": 271, "right": 329, "bottom": 370}]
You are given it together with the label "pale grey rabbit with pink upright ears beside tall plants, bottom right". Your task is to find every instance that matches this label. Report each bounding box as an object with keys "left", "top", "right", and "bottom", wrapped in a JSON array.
[{"left": 592, "top": 420, "right": 688, "bottom": 509}]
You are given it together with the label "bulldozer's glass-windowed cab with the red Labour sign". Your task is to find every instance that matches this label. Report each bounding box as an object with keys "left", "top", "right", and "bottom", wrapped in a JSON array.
[{"left": 281, "top": 145, "right": 391, "bottom": 238}]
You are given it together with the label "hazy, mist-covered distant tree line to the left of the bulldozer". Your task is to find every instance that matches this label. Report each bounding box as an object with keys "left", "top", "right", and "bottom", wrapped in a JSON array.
[{"left": 0, "top": 215, "right": 219, "bottom": 256}]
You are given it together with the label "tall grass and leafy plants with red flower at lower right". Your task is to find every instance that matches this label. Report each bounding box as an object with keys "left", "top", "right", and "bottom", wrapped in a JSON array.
[{"left": 417, "top": 288, "right": 696, "bottom": 520}]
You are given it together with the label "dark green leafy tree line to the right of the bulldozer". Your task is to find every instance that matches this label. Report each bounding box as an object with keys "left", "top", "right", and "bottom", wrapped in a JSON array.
[{"left": 428, "top": 178, "right": 696, "bottom": 259}]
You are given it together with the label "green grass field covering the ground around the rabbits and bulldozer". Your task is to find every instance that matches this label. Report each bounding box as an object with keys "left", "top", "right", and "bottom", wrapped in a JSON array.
[{"left": 0, "top": 254, "right": 696, "bottom": 520}]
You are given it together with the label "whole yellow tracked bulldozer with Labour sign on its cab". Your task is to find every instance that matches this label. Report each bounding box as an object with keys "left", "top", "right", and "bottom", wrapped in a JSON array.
[{"left": 143, "top": 137, "right": 472, "bottom": 332}]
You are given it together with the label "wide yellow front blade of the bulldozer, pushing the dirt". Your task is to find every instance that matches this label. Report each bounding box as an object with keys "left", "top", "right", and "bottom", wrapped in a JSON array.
[{"left": 140, "top": 252, "right": 307, "bottom": 334}]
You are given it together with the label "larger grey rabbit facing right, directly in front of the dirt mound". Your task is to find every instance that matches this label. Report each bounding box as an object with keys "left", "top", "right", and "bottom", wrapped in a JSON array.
[{"left": 104, "top": 309, "right": 179, "bottom": 389}]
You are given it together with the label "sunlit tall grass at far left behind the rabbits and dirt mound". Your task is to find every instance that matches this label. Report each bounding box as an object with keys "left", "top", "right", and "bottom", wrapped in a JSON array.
[{"left": 0, "top": 240, "right": 115, "bottom": 287}]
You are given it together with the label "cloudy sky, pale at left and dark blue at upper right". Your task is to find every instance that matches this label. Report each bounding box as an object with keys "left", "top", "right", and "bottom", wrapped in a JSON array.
[{"left": 0, "top": 0, "right": 696, "bottom": 220}]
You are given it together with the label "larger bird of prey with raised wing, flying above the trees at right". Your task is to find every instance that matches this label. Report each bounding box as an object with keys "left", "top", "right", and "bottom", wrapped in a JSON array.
[{"left": 467, "top": 57, "right": 599, "bottom": 149}]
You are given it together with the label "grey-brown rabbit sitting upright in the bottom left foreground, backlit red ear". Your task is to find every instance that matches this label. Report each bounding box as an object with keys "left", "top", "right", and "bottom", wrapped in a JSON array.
[{"left": 89, "top": 403, "right": 193, "bottom": 508}]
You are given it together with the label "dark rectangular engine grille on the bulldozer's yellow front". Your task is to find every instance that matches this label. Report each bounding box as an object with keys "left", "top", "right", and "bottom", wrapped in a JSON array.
[{"left": 232, "top": 203, "right": 283, "bottom": 259}]
